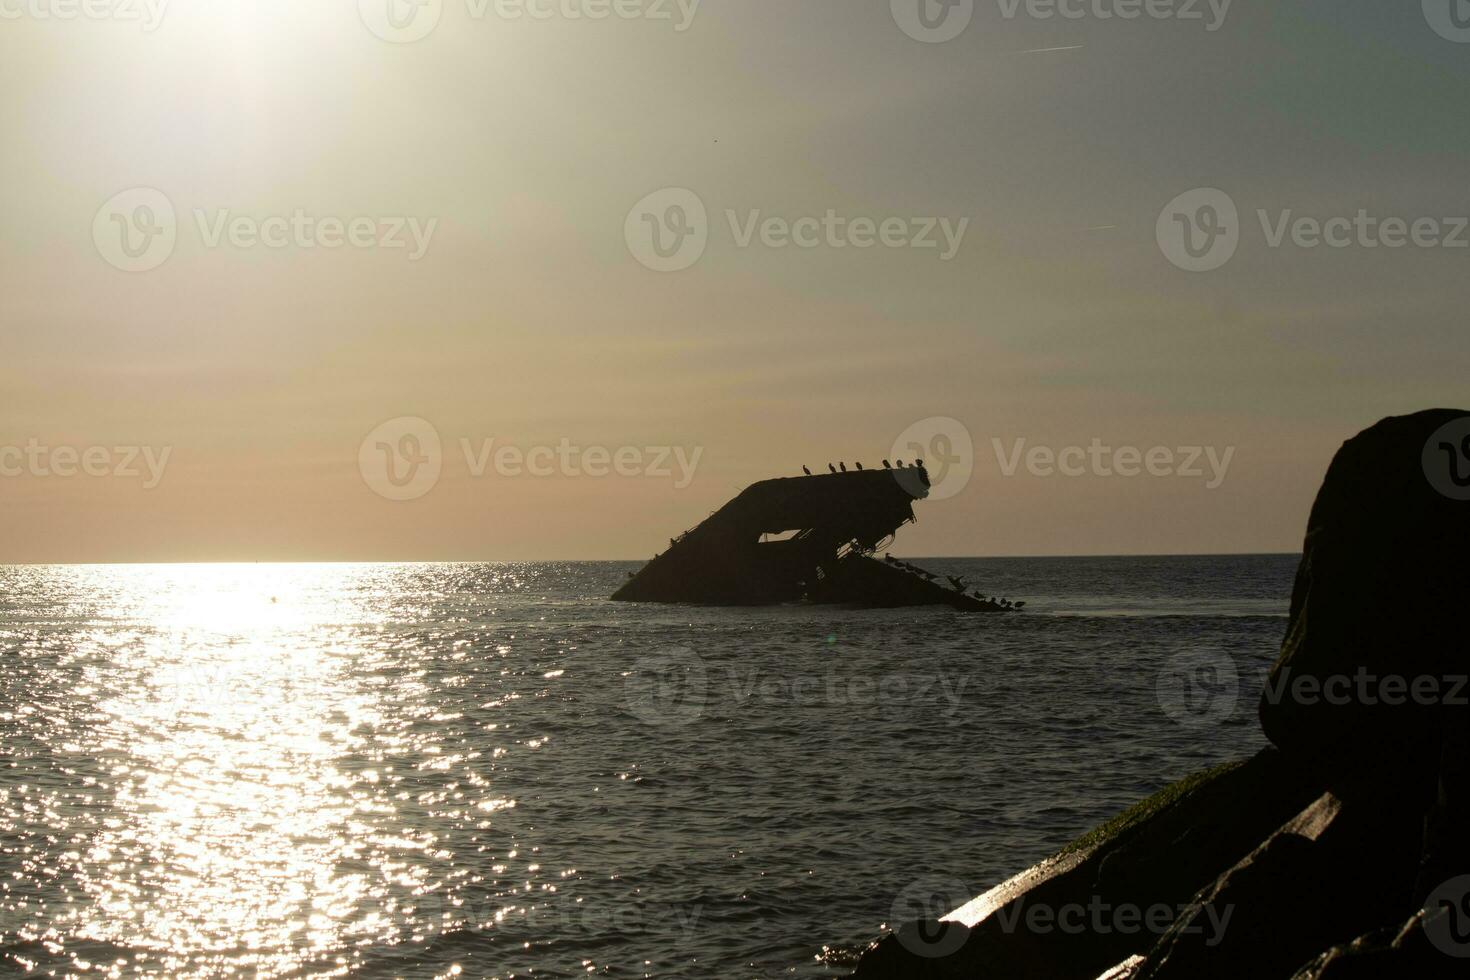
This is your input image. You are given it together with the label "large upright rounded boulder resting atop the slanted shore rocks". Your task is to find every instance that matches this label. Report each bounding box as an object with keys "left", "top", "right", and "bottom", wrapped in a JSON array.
[{"left": 1260, "top": 410, "right": 1470, "bottom": 761}]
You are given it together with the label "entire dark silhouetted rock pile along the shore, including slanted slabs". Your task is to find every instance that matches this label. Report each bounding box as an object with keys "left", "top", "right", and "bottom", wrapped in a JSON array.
[{"left": 854, "top": 410, "right": 1470, "bottom": 980}]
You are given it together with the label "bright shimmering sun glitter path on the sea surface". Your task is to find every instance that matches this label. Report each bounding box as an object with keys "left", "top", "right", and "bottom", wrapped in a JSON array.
[{"left": 1, "top": 566, "right": 499, "bottom": 977}]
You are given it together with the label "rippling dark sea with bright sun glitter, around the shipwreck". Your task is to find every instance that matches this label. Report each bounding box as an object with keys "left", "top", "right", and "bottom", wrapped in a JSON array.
[{"left": 0, "top": 555, "right": 1297, "bottom": 979}]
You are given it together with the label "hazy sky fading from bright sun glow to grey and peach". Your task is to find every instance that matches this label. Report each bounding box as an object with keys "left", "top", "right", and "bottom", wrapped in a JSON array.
[{"left": 0, "top": 0, "right": 1470, "bottom": 561}]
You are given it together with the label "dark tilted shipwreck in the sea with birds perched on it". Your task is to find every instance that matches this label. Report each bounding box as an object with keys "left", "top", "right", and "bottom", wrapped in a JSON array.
[{"left": 613, "top": 463, "right": 1025, "bottom": 613}]
